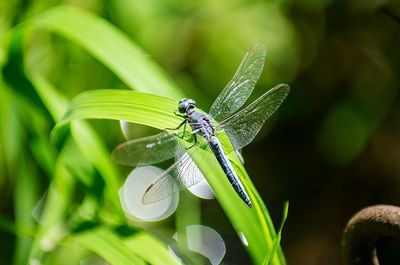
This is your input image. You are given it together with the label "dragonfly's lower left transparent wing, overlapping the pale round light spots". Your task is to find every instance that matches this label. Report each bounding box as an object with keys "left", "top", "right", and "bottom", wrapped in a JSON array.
[{"left": 142, "top": 148, "right": 204, "bottom": 204}]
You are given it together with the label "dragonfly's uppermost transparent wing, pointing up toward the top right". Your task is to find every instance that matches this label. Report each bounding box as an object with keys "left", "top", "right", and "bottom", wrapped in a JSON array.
[{"left": 209, "top": 45, "right": 265, "bottom": 121}]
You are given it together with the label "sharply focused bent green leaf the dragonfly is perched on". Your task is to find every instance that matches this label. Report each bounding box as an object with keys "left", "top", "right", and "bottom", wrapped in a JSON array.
[{"left": 56, "top": 90, "right": 285, "bottom": 264}]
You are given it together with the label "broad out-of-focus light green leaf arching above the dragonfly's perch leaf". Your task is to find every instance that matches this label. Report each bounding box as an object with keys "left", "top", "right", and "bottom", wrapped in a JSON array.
[{"left": 28, "top": 6, "right": 182, "bottom": 99}]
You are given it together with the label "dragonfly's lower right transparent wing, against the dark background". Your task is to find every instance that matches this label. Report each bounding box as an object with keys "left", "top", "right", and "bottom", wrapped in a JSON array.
[{"left": 220, "top": 84, "right": 290, "bottom": 150}]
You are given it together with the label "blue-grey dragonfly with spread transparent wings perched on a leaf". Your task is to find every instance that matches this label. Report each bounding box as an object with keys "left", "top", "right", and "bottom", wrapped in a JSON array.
[{"left": 111, "top": 44, "right": 290, "bottom": 207}]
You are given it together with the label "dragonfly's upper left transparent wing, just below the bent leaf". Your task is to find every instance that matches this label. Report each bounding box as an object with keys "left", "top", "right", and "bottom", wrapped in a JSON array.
[{"left": 111, "top": 132, "right": 178, "bottom": 166}]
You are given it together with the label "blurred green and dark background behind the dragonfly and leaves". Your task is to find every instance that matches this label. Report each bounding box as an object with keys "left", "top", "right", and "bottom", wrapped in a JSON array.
[{"left": 0, "top": 0, "right": 400, "bottom": 265}]
